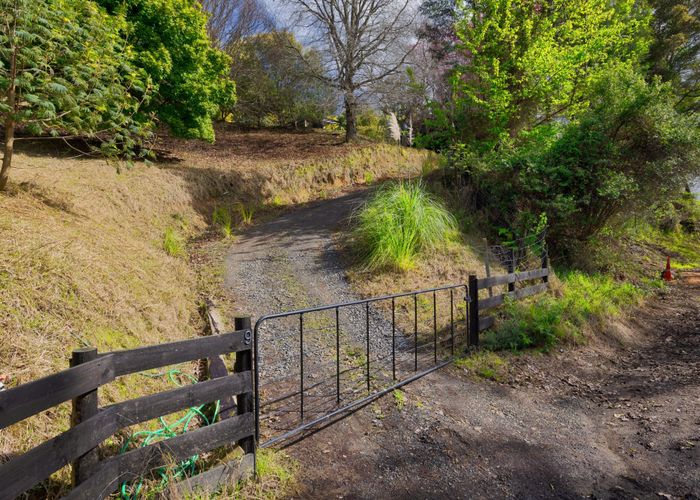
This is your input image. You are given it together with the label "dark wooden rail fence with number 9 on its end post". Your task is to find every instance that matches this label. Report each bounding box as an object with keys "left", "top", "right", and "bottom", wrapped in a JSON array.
[{"left": 0, "top": 318, "right": 255, "bottom": 500}]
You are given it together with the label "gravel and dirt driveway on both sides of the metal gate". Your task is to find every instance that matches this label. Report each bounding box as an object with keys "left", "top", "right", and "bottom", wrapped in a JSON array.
[{"left": 227, "top": 195, "right": 700, "bottom": 499}]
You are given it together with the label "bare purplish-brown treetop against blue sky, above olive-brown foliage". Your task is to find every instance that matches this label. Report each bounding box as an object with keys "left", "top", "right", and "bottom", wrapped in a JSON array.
[{"left": 200, "top": 0, "right": 275, "bottom": 49}]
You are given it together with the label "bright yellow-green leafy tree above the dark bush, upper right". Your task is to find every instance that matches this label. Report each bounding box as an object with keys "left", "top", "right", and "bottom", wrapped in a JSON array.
[{"left": 453, "top": 0, "right": 649, "bottom": 143}]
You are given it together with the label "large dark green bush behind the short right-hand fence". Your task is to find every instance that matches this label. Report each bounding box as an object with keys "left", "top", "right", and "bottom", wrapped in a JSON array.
[{"left": 455, "top": 66, "right": 700, "bottom": 247}]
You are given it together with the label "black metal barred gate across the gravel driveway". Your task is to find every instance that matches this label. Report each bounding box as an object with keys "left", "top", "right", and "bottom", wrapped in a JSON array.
[{"left": 254, "top": 285, "right": 471, "bottom": 447}]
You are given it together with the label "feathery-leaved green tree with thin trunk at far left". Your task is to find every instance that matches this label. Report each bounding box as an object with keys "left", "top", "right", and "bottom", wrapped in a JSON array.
[{"left": 0, "top": 0, "right": 149, "bottom": 190}]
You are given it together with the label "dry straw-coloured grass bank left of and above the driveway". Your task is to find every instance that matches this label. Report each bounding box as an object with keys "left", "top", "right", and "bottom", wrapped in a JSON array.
[{"left": 0, "top": 128, "right": 428, "bottom": 492}]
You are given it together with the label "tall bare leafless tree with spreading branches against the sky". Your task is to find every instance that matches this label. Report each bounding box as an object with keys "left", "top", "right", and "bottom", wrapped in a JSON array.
[{"left": 290, "top": 0, "right": 414, "bottom": 141}]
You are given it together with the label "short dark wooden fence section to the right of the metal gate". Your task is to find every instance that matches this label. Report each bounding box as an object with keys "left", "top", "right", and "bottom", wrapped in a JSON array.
[{"left": 469, "top": 257, "right": 549, "bottom": 346}]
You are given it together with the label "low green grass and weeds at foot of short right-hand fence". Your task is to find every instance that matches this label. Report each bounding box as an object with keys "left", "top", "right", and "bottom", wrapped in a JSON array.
[{"left": 482, "top": 271, "right": 644, "bottom": 350}]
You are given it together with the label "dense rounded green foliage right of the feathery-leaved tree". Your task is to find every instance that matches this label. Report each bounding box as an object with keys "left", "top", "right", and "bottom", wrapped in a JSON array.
[{"left": 98, "top": 0, "right": 235, "bottom": 141}]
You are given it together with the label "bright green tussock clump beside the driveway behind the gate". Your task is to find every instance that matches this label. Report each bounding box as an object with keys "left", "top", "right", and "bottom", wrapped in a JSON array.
[{"left": 353, "top": 182, "right": 458, "bottom": 271}]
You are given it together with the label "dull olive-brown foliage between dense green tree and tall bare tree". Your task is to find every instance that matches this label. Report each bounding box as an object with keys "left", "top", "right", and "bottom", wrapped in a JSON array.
[{"left": 226, "top": 32, "right": 333, "bottom": 127}]
